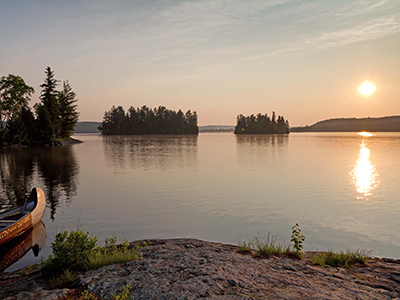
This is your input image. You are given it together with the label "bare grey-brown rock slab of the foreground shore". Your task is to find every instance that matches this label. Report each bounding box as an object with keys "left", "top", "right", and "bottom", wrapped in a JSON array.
[{"left": 0, "top": 239, "right": 400, "bottom": 300}]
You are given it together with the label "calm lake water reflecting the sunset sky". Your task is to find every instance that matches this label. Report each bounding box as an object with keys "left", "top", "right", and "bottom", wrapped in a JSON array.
[{"left": 0, "top": 133, "right": 400, "bottom": 270}]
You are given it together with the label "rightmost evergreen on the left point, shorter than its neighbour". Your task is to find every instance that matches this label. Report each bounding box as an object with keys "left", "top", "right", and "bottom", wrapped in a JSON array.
[{"left": 58, "top": 81, "right": 79, "bottom": 139}]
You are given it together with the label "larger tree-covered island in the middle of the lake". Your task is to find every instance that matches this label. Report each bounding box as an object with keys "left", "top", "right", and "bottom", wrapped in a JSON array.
[{"left": 99, "top": 105, "right": 199, "bottom": 135}]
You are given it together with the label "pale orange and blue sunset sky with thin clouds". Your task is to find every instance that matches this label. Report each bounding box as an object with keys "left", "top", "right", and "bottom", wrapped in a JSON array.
[{"left": 0, "top": 0, "right": 400, "bottom": 126}]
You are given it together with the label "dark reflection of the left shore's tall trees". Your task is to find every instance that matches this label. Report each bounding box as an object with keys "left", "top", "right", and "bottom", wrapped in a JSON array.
[{"left": 0, "top": 146, "right": 79, "bottom": 220}]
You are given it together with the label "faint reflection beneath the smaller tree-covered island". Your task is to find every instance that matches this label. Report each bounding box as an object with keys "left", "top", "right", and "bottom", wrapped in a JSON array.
[{"left": 236, "top": 134, "right": 289, "bottom": 169}]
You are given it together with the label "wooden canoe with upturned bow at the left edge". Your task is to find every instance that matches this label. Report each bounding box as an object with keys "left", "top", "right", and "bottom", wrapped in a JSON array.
[{"left": 0, "top": 188, "right": 46, "bottom": 245}]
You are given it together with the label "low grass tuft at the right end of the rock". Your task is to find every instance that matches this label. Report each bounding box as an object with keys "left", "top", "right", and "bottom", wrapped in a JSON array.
[{"left": 310, "top": 250, "right": 368, "bottom": 269}]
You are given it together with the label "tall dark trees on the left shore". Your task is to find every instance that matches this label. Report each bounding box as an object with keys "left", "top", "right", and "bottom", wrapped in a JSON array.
[{"left": 0, "top": 67, "right": 79, "bottom": 147}]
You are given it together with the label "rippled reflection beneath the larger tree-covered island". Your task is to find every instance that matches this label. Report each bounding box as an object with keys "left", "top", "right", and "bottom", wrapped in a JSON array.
[{"left": 103, "top": 135, "right": 197, "bottom": 171}]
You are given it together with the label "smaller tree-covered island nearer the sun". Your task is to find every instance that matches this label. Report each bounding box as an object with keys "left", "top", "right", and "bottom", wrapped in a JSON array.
[{"left": 235, "top": 112, "right": 289, "bottom": 134}]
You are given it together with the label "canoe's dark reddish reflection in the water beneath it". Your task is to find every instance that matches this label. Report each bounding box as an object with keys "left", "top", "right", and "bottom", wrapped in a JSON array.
[{"left": 0, "top": 221, "right": 46, "bottom": 272}]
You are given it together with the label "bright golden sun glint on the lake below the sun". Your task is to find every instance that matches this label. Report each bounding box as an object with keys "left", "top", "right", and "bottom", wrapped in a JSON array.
[{"left": 350, "top": 132, "right": 379, "bottom": 197}]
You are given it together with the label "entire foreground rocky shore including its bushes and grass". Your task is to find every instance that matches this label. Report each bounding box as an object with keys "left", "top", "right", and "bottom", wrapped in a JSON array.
[{"left": 0, "top": 230, "right": 400, "bottom": 300}]
